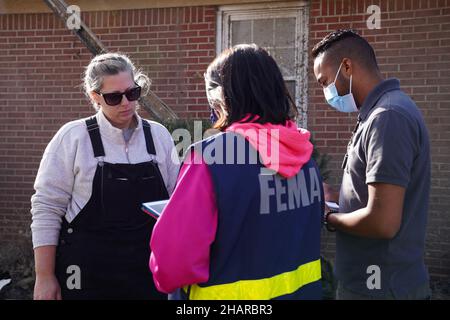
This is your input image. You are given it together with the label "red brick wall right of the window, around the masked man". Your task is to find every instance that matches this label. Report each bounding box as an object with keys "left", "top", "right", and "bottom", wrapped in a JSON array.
[{"left": 308, "top": 0, "right": 450, "bottom": 279}]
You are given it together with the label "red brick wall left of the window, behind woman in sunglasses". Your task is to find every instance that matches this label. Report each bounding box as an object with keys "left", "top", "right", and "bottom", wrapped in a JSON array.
[{"left": 0, "top": 7, "right": 216, "bottom": 241}]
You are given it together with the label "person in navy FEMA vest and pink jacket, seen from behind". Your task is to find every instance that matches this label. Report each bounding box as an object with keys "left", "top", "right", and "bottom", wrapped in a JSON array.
[{"left": 150, "top": 44, "right": 324, "bottom": 300}]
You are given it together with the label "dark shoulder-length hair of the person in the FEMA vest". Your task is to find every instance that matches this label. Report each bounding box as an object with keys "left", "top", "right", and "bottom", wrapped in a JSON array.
[{"left": 205, "top": 44, "right": 298, "bottom": 130}]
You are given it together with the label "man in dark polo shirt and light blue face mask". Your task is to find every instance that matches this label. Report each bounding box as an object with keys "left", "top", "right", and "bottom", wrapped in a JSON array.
[{"left": 312, "top": 30, "right": 430, "bottom": 299}]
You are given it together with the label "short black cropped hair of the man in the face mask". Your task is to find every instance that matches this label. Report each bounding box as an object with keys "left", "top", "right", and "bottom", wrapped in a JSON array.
[{"left": 312, "top": 29, "right": 378, "bottom": 70}]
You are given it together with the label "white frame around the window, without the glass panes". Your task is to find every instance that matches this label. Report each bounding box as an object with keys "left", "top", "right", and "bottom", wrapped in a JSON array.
[{"left": 216, "top": 1, "right": 309, "bottom": 128}]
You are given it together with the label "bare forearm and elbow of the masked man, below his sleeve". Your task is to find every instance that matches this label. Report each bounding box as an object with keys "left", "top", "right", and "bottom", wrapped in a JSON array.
[{"left": 328, "top": 183, "right": 405, "bottom": 239}]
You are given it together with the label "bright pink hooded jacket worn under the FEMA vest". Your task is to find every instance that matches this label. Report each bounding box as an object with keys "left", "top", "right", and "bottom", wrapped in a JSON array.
[{"left": 149, "top": 121, "right": 313, "bottom": 293}]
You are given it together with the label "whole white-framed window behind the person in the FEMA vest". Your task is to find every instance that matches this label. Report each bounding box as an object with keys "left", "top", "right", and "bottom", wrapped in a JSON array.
[{"left": 217, "top": 1, "right": 308, "bottom": 127}]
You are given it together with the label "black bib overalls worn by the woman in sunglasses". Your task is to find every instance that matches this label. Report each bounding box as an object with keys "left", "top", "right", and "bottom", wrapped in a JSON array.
[{"left": 55, "top": 117, "right": 169, "bottom": 300}]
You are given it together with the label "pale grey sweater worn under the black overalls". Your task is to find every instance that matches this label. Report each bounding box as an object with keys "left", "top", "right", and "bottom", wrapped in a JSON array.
[{"left": 31, "top": 111, "right": 179, "bottom": 248}]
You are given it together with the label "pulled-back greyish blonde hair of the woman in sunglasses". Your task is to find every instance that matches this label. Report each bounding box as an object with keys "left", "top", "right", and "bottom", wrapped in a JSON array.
[{"left": 83, "top": 52, "right": 151, "bottom": 110}]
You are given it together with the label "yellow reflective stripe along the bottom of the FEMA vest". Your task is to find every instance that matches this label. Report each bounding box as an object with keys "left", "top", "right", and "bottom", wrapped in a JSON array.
[{"left": 184, "top": 259, "right": 321, "bottom": 300}]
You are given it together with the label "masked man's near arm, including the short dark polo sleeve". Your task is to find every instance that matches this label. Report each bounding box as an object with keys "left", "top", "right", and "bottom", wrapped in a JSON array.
[{"left": 328, "top": 108, "right": 419, "bottom": 239}]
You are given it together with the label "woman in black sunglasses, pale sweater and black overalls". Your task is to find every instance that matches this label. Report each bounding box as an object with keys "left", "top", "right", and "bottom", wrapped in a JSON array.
[{"left": 31, "top": 53, "right": 178, "bottom": 299}]
